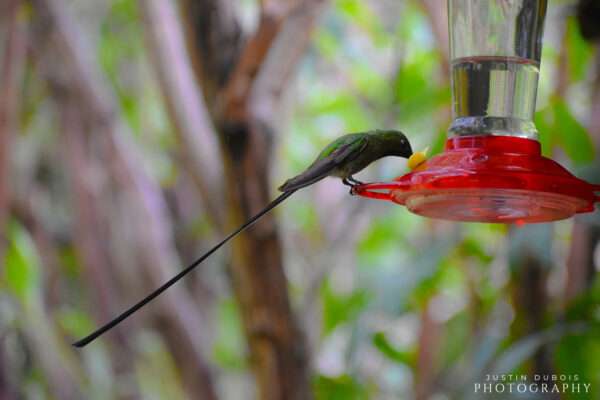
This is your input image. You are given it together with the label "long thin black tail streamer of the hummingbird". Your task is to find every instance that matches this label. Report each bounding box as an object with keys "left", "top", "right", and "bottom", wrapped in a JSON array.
[{"left": 73, "top": 190, "right": 296, "bottom": 347}]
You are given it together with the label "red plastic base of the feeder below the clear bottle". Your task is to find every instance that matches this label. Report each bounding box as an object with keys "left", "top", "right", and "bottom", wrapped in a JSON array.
[{"left": 354, "top": 136, "right": 600, "bottom": 223}]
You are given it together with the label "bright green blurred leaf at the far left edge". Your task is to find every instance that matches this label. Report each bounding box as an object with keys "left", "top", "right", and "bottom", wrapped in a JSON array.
[{"left": 4, "top": 222, "right": 40, "bottom": 302}]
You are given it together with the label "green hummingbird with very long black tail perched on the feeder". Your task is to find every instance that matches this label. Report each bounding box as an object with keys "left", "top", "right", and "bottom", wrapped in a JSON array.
[{"left": 73, "top": 129, "right": 413, "bottom": 347}]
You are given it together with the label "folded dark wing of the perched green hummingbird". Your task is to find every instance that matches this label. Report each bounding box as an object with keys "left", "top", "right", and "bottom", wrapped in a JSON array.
[{"left": 279, "top": 136, "right": 368, "bottom": 192}]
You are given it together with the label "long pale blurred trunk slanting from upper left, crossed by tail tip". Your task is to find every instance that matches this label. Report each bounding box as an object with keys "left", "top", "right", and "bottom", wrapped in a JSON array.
[{"left": 32, "top": 0, "right": 216, "bottom": 399}]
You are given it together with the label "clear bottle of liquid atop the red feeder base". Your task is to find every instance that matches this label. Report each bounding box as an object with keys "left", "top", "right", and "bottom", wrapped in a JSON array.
[{"left": 448, "top": 0, "right": 547, "bottom": 139}]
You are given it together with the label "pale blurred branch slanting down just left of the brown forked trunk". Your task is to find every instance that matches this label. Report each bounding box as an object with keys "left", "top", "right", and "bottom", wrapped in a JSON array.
[{"left": 139, "top": 0, "right": 225, "bottom": 231}]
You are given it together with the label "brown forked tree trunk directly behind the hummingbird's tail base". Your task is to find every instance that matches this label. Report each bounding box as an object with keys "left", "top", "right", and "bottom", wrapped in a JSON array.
[{"left": 182, "top": 0, "right": 324, "bottom": 399}]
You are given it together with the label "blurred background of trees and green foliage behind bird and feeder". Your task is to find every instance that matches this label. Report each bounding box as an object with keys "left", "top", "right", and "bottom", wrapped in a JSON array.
[{"left": 0, "top": 0, "right": 600, "bottom": 400}]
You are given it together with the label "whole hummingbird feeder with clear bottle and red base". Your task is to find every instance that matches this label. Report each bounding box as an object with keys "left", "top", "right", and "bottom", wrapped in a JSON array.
[{"left": 354, "top": 0, "right": 600, "bottom": 223}]
